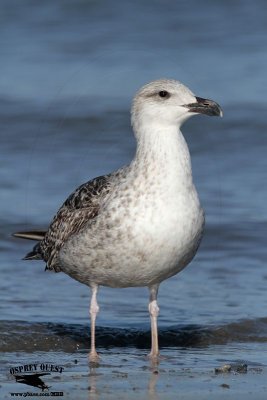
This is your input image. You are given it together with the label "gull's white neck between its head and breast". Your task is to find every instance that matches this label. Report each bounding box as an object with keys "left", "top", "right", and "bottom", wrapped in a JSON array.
[{"left": 131, "top": 123, "right": 192, "bottom": 185}]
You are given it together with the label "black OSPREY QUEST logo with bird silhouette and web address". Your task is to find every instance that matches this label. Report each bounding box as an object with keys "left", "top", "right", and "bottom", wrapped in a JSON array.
[{"left": 9, "top": 363, "right": 64, "bottom": 397}]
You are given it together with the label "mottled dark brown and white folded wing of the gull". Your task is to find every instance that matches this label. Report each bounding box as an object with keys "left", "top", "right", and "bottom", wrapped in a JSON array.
[{"left": 32, "top": 175, "right": 110, "bottom": 272}]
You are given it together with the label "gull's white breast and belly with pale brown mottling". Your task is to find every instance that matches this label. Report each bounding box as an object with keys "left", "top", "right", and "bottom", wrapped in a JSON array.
[{"left": 60, "top": 129, "right": 204, "bottom": 287}]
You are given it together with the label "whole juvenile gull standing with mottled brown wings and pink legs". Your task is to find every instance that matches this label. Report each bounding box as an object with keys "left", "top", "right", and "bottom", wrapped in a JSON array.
[{"left": 14, "top": 79, "right": 222, "bottom": 361}]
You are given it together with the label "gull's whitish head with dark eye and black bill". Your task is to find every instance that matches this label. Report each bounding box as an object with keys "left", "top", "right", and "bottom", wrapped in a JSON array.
[{"left": 132, "top": 79, "right": 222, "bottom": 131}]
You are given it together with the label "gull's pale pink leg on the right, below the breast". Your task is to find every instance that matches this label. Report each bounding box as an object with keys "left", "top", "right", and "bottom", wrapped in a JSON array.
[{"left": 148, "top": 285, "right": 159, "bottom": 359}]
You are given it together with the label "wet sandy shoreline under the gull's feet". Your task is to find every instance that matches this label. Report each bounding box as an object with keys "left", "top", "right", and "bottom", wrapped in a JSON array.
[{"left": 0, "top": 349, "right": 267, "bottom": 400}]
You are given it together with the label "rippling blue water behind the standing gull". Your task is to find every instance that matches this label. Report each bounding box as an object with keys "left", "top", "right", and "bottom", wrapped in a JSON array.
[{"left": 0, "top": 0, "right": 267, "bottom": 398}]
